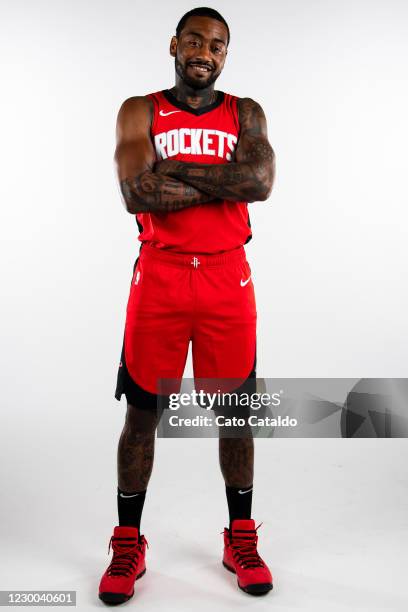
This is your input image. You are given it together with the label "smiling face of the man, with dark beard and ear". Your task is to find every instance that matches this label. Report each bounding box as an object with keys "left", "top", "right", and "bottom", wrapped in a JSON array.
[{"left": 170, "top": 16, "right": 228, "bottom": 89}]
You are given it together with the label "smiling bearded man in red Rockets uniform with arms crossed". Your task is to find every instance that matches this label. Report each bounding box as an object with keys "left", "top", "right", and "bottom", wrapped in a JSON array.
[{"left": 99, "top": 8, "right": 274, "bottom": 603}]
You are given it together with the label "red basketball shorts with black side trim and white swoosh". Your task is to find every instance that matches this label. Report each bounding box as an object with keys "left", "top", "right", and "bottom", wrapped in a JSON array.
[{"left": 115, "top": 244, "right": 257, "bottom": 407}]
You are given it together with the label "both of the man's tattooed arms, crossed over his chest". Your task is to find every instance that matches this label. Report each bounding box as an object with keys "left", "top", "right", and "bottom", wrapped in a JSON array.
[{"left": 115, "top": 97, "right": 275, "bottom": 214}]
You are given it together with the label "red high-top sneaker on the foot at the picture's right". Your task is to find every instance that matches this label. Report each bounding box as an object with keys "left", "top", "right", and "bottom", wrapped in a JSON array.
[{"left": 222, "top": 519, "right": 273, "bottom": 595}]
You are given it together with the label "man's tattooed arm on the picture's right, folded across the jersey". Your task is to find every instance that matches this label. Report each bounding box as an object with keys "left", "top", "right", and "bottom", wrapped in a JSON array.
[{"left": 157, "top": 98, "right": 275, "bottom": 202}]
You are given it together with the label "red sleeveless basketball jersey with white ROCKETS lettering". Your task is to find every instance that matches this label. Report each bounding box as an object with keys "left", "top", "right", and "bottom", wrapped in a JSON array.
[{"left": 136, "top": 90, "right": 251, "bottom": 254}]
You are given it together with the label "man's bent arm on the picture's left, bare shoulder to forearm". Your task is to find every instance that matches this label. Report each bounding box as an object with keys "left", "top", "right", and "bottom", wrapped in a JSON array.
[{"left": 115, "top": 97, "right": 214, "bottom": 214}]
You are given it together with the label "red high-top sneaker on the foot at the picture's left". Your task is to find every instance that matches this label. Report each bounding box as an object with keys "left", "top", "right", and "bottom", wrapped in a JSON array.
[{"left": 99, "top": 527, "right": 147, "bottom": 604}]
